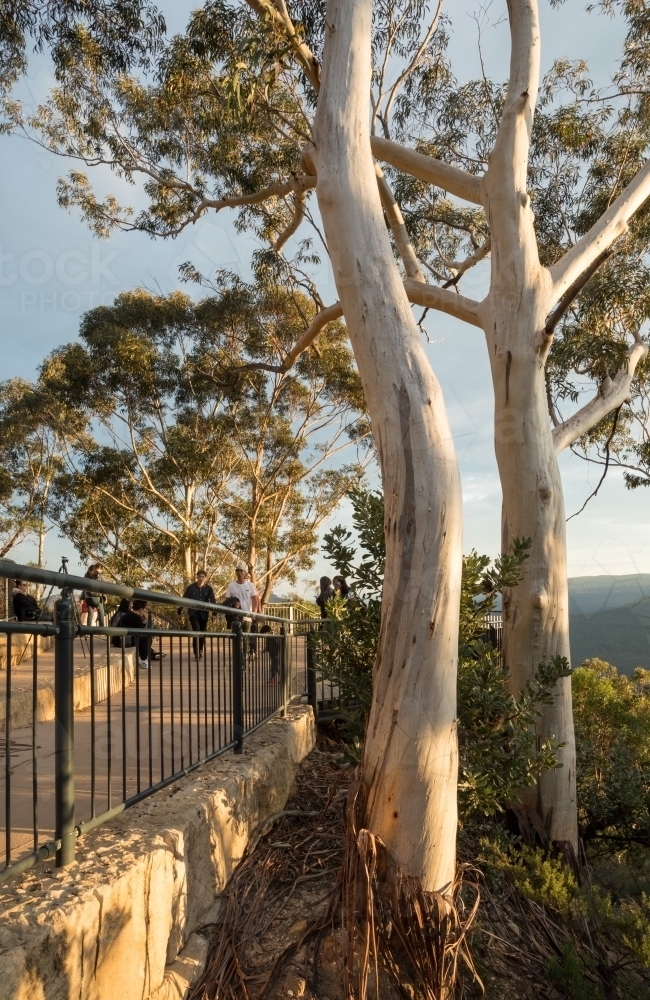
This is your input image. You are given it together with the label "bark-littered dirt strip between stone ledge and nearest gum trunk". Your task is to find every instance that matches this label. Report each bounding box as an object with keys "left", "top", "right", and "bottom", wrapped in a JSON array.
[{"left": 191, "top": 736, "right": 354, "bottom": 1000}]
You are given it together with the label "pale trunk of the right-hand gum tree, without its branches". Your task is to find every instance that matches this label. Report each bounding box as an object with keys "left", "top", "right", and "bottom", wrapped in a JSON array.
[{"left": 482, "top": 0, "right": 578, "bottom": 849}]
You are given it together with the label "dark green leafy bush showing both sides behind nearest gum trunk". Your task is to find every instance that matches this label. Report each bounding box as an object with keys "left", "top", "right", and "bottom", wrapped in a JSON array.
[{"left": 317, "top": 488, "right": 568, "bottom": 820}]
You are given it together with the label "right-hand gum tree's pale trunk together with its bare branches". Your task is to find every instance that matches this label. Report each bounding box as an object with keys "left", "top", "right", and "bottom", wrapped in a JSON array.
[{"left": 373, "top": 0, "right": 650, "bottom": 848}]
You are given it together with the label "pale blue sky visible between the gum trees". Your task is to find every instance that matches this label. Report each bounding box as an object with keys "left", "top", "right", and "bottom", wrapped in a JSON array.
[{"left": 0, "top": 0, "right": 650, "bottom": 579}]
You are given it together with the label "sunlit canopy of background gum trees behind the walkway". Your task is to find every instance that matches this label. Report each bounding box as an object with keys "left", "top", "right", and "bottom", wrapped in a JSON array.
[{"left": 39, "top": 275, "right": 366, "bottom": 594}]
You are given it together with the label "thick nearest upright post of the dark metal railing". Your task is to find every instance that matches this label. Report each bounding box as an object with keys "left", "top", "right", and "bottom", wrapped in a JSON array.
[{"left": 54, "top": 588, "right": 76, "bottom": 868}]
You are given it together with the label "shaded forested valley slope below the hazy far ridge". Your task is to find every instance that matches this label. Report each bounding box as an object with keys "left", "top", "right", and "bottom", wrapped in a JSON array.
[{"left": 570, "top": 598, "right": 650, "bottom": 674}]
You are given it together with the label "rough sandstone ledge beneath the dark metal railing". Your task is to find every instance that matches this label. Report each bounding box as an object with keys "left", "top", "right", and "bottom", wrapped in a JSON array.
[{"left": 0, "top": 704, "right": 315, "bottom": 1000}]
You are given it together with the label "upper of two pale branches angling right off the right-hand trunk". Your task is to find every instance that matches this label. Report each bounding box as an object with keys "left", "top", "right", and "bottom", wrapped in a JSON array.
[{"left": 551, "top": 160, "right": 650, "bottom": 299}]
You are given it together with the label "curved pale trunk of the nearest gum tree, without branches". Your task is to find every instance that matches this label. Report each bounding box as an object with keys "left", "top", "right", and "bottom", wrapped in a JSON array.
[{"left": 312, "top": 0, "right": 462, "bottom": 890}]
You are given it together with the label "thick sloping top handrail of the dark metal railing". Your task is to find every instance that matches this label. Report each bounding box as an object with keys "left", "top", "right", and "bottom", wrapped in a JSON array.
[{"left": 0, "top": 559, "right": 317, "bottom": 625}]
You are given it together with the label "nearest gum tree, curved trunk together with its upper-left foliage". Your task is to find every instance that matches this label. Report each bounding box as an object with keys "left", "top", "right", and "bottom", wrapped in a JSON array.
[{"left": 34, "top": 0, "right": 464, "bottom": 889}]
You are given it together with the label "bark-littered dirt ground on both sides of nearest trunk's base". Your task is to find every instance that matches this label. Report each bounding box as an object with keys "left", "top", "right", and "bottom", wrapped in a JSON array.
[{"left": 190, "top": 733, "right": 584, "bottom": 1000}]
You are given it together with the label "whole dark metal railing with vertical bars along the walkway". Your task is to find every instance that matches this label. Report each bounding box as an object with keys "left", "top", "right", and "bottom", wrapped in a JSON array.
[{"left": 0, "top": 560, "right": 320, "bottom": 882}]
